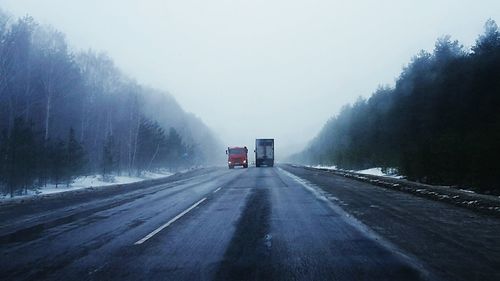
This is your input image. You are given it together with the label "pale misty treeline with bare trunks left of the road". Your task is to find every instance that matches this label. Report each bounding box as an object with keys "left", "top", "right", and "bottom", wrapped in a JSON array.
[{"left": 0, "top": 11, "right": 217, "bottom": 195}]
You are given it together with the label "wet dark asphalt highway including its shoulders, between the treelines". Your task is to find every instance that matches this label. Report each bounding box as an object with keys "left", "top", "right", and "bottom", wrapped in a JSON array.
[{"left": 0, "top": 166, "right": 500, "bottom": 281}]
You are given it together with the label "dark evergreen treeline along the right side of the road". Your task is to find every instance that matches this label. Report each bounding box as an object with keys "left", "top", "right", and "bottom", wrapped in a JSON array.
[{"left": 293, "top": 20, "right": 500, "bottom": 193}]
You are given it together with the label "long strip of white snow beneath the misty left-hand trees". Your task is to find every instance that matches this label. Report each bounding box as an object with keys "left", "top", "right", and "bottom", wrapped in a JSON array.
[{"left": 0, "top": 168, "right": 173, "bottom": 200}]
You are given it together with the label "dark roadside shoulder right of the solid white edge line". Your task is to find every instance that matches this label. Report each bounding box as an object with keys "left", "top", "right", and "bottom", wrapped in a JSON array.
[{"left": 282, "top": 165, "right": 500, "bottom": 281}]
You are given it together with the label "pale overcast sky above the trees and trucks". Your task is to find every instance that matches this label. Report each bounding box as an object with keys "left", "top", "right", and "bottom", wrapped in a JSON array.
[{"left": 0, "top": 0, "right": 500, "bottom": 156}]
